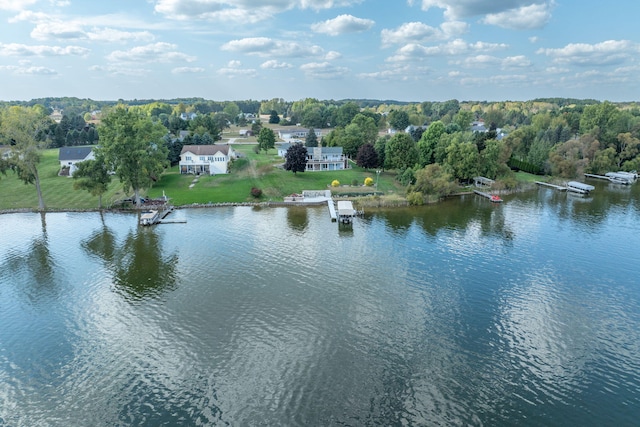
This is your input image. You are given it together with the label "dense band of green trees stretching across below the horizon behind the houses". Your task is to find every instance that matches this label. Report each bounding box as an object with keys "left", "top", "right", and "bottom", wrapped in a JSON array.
[{"left": 0, "top": 98, "right": 640, "bottom": 208}]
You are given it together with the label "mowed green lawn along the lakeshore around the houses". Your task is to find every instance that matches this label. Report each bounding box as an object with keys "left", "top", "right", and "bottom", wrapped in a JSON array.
[{"left": 0, "top": 145, "right": 402, "bottom": 210}]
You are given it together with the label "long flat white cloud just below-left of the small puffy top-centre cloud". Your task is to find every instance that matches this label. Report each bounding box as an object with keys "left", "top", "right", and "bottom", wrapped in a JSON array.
[{"left": 221, "top": 37, "right": 324, "bottom": 58}]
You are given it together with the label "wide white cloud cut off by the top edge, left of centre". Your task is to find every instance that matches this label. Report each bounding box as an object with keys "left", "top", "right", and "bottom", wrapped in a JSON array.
[{"left": 155, "top": 0, "right": 363, "bottom": 23}]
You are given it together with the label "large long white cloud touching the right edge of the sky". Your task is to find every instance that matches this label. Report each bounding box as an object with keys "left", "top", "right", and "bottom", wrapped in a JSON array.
[{"left": 536, "top": 40, "right": 640, "bottom": 66}]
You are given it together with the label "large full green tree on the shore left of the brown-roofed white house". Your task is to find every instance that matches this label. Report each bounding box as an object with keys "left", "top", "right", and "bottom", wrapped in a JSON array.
[{"left": 96, "top": 105, "right": 168, "bottom": 207}]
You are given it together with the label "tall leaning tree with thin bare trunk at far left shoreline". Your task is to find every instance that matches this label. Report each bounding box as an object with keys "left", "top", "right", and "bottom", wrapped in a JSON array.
[{"left": 0, "top": 106, "right": 51, "bottom": 211}]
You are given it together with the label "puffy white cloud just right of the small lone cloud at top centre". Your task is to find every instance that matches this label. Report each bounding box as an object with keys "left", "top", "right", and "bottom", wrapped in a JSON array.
[{"left": 380, "top": 21, "right": 469, "bottom": 46}]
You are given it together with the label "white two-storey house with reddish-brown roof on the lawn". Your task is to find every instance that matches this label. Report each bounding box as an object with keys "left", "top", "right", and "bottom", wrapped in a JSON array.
[{"left": 179, "top": 144, "right": 236, "bottom": 175}]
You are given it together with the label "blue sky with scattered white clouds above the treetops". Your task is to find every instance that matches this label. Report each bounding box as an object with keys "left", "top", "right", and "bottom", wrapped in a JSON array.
[{"left": 0, "top": 0, "right": 640, "bottom": 102}]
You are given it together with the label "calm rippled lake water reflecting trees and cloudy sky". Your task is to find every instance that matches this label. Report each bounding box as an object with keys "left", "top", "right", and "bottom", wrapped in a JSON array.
[{"left": 0, "top": 183, "right": 640, "bottom": 427}]
